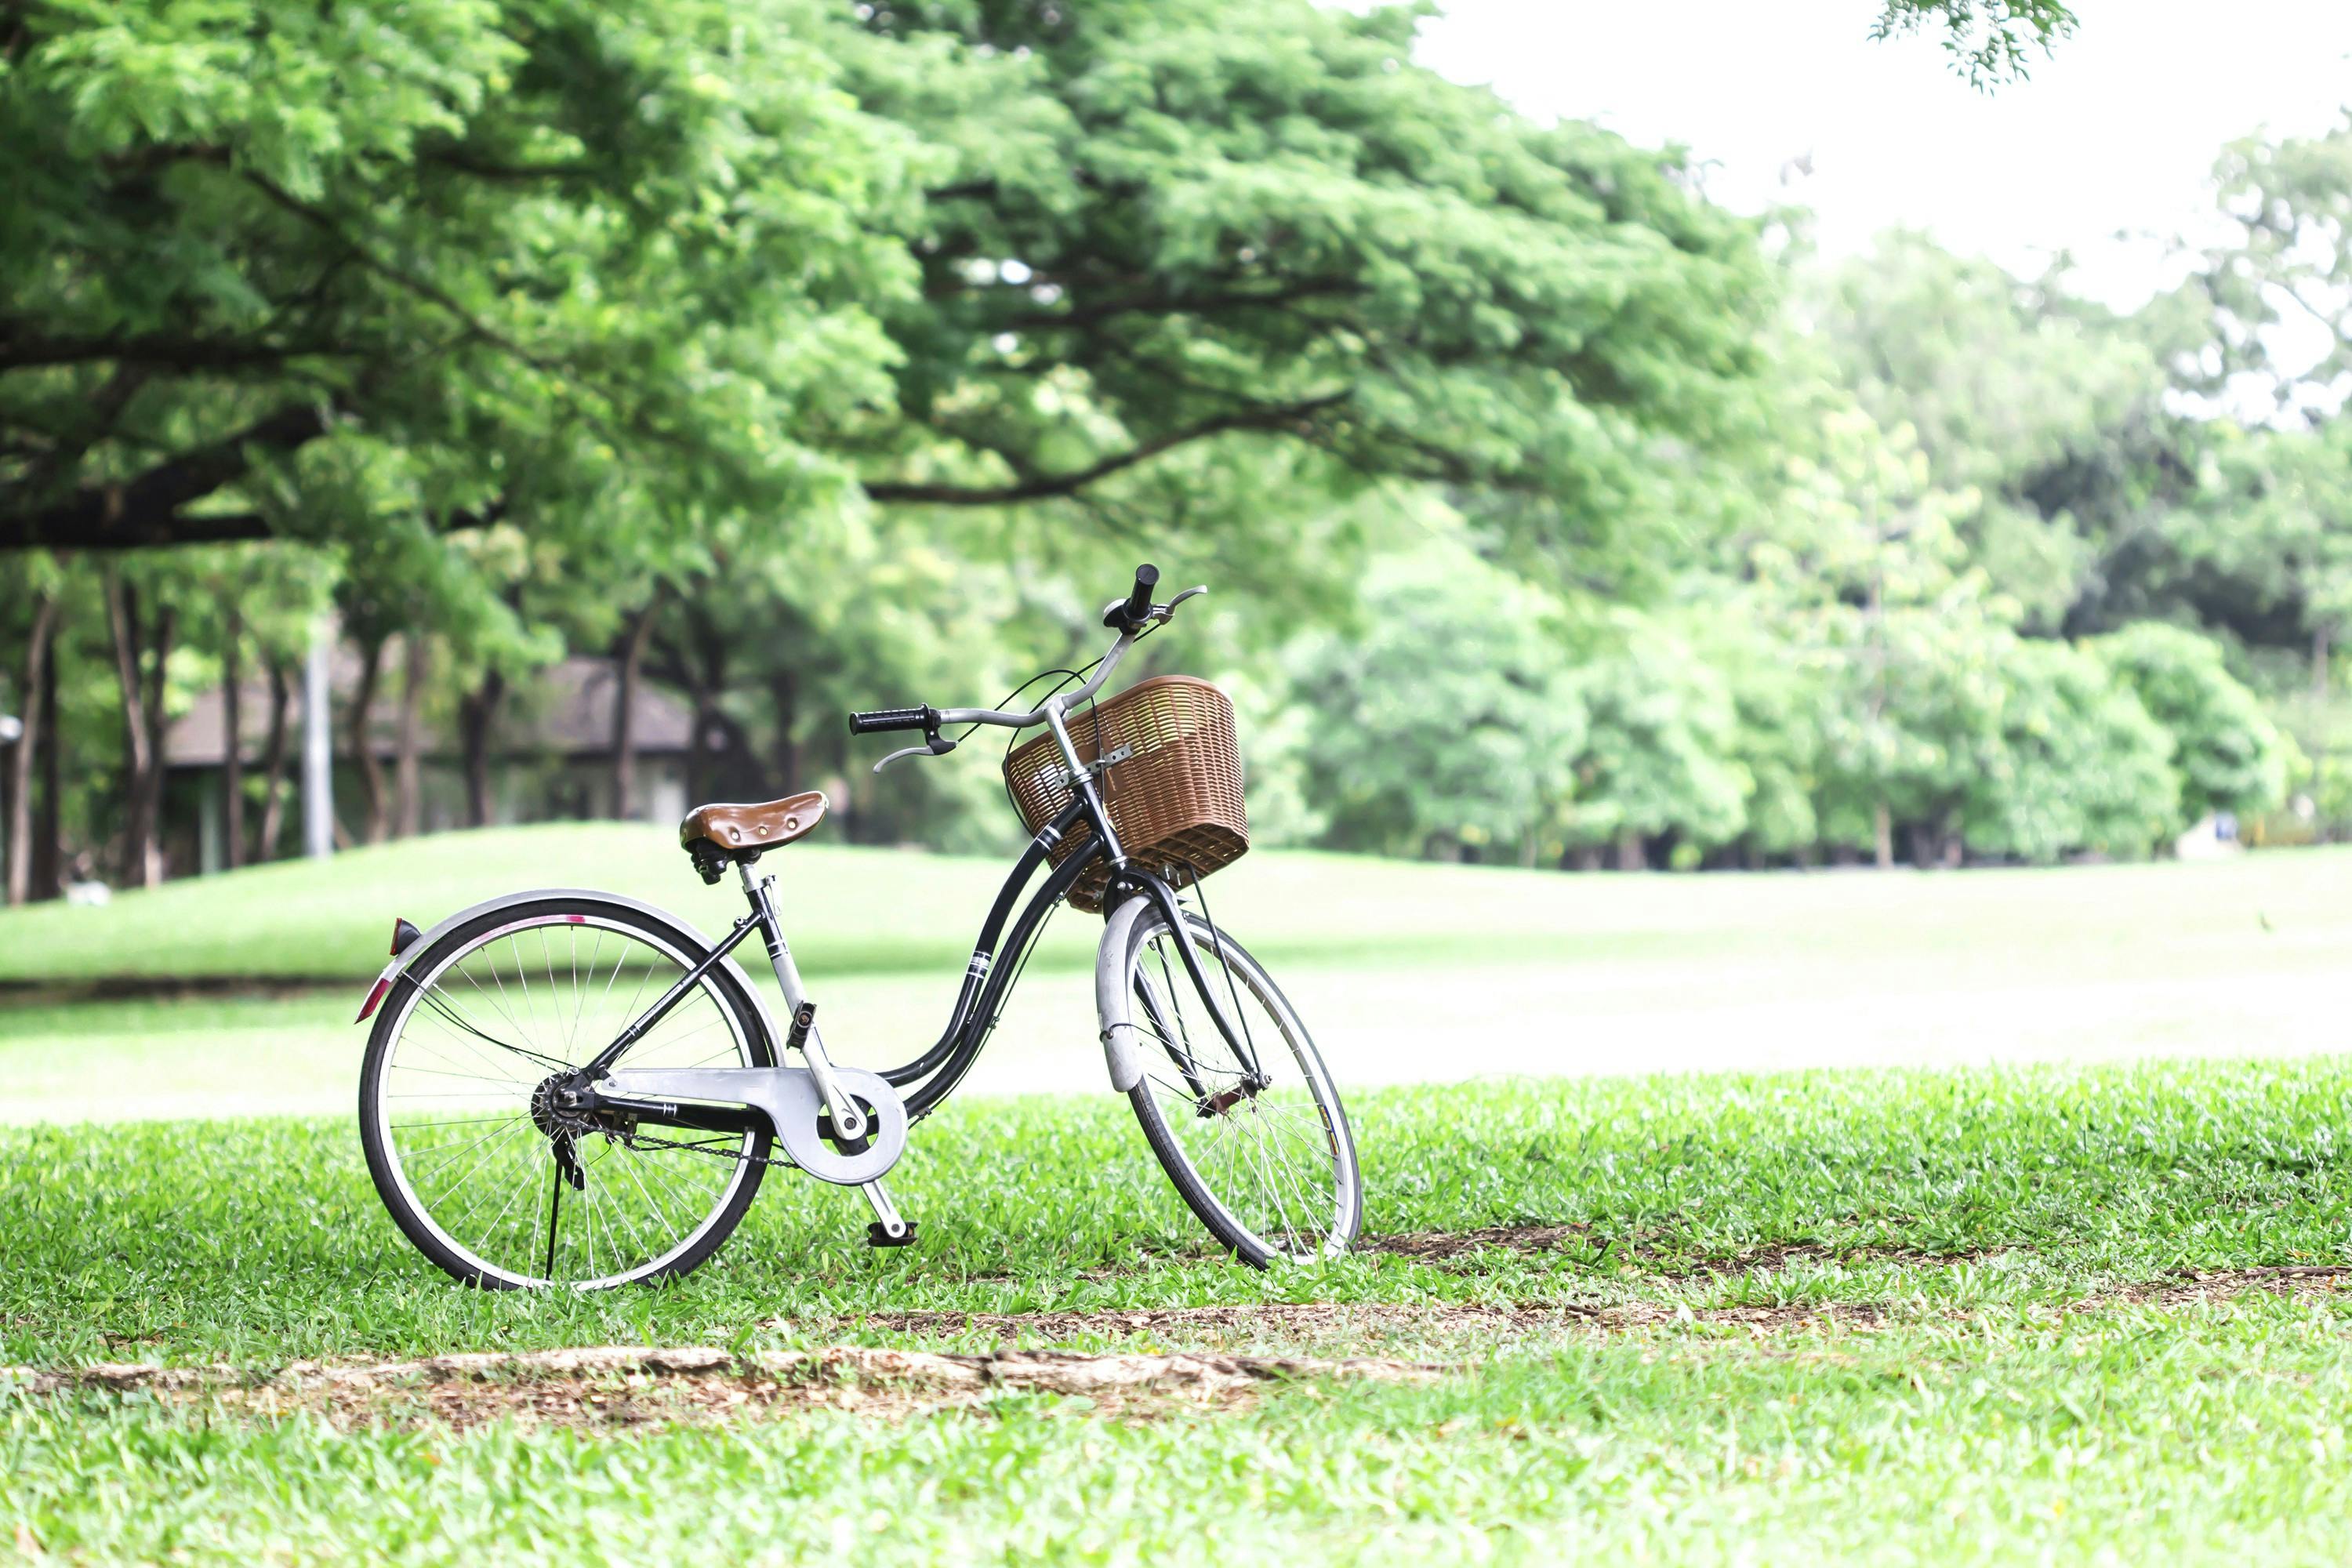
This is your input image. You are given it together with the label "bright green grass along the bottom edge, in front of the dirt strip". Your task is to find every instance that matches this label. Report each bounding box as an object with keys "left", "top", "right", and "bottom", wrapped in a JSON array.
[{"left": 13, "top": 1302, "right": 2352, "bottom": 1563}]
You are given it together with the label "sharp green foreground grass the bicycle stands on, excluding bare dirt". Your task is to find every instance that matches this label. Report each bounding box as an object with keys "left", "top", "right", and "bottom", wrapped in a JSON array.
[{"left": 0, "top": 1060, "right": 2352, "bottom": 1563}]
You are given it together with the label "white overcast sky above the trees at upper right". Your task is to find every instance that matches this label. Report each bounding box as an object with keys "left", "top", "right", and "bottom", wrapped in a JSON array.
[{"left": 1418, "top": 0, "right": 2352, "bottom": 308}]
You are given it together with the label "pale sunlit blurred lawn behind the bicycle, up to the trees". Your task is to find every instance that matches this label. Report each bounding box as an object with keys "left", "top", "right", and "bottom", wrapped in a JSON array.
[{"left": 0, "top": 825, "right": 2352, "bottom": 1123}]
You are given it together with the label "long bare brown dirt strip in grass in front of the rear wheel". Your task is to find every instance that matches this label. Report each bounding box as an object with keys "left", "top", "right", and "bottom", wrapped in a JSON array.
[{"left": 0, "top": 1345, "right": 1444, "bottom": 1427}]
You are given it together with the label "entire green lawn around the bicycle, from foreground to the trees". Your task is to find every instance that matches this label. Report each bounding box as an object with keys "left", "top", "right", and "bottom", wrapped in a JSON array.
[{"left": 0, "top": 851, "right": 2352, "bottom": 1563}]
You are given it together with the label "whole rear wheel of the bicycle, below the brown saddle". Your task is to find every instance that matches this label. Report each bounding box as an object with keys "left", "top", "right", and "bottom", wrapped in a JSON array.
[{"left": 360, "top": 895, "right": 776, "bottom": 1290}]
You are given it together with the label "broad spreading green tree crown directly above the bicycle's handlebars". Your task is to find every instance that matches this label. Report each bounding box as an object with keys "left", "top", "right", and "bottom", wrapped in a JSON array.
[{"left": 840, "top": 0, "right": 1771, "bottom": 573}]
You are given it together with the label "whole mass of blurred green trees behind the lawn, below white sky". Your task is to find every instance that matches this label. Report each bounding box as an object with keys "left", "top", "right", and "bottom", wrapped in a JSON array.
[{"left": 0, "top": 0, "right": 2352, "bottom": 898}]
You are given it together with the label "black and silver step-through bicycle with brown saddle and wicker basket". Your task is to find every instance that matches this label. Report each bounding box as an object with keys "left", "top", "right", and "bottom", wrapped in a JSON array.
[{"left": 358, "top": 567, "right": 1364, "bottom": 1290}]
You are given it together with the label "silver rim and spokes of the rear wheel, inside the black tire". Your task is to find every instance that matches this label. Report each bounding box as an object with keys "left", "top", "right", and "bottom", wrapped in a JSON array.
[{"left": 374, "top": 914, "right": 757, "bottom": 1290}]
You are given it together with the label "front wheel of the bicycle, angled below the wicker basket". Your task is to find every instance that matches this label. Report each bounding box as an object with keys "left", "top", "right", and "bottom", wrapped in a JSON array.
[{"left": 1122, "top": 909, "right": 1364, "bottom": 1269}]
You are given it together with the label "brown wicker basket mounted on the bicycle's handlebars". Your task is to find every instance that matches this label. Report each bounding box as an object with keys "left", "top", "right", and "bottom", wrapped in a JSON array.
[{"left": 1004, "top": 675, "right": 1249, "bottom": 909}]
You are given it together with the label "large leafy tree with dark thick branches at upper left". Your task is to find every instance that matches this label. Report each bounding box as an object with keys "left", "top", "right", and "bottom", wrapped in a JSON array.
[{"left": 0, "top": 0, "right": 910, "bottom": 550}]
